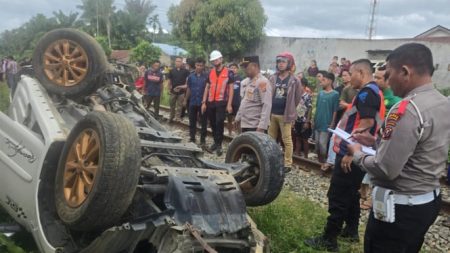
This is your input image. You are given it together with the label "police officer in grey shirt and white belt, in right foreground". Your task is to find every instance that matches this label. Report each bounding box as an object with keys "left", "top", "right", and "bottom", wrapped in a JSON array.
[{"left": 349, "top": 43, "right": 450, "bottom": 253}]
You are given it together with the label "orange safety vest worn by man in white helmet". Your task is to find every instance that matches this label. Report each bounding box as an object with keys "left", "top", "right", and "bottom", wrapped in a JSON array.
[{"left": 208, "top": 67, "right": 229, "bottom": 102}]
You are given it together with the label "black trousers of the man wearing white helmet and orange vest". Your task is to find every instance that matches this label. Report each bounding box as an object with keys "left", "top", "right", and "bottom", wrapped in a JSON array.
[{"left": 207, "top": 103, "right": 227, "bottom": 146}]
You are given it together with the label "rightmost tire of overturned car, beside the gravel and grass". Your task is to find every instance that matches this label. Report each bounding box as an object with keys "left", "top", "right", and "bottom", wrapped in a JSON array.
[{"left": 225, "top": 132, "right": 285, "bottom": 206}]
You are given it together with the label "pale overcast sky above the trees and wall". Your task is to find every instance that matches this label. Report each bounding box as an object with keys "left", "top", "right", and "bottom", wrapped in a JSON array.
[{"left": 0, "top": 0, "right": 450, "bottom": 38}]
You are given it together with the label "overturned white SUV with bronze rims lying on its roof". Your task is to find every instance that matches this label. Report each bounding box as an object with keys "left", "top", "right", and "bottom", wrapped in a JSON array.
[{"left": 0, "top": 29, "right": 284, "bottom": 253}]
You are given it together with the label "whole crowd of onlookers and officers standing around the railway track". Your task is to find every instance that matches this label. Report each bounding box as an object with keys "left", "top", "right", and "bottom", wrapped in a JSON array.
[{"left": 137, "top": 43, "right": 450, "bottom": 252}]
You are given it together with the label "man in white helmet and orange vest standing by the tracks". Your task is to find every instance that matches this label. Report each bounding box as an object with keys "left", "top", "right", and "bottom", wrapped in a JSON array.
[{"left": 202, "top": 50, "right": 234, "bottom": 156}]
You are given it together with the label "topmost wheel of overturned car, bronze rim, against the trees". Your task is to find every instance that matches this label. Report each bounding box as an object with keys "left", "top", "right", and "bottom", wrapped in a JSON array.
[{"left": 33, "top": 28, "right": 108, "bottom": 98}]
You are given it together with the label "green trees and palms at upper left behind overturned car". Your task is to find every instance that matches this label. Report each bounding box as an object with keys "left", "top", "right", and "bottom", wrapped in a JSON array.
[{"left": 0, "top": 0, "right": 159, "bottom": 58}]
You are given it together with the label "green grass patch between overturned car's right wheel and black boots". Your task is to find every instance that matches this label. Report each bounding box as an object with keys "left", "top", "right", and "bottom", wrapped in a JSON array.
[{"left": 249, "top": 191, "right": 363, "bottom": 253}]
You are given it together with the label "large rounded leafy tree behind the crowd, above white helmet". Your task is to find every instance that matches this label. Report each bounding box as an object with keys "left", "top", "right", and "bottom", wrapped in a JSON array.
[{"left": 168, "top": 0, "right": 267, "bottom": 59}]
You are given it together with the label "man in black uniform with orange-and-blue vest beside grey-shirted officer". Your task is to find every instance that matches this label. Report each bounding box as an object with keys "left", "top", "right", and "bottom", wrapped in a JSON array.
[{"left": 305, "top": 59, "right": 386, "bottom": 252}]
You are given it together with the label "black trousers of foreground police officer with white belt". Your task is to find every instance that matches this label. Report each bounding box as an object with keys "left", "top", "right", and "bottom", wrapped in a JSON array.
[{"left": 364, "top": 196, "right": 442, "bottom": 253}]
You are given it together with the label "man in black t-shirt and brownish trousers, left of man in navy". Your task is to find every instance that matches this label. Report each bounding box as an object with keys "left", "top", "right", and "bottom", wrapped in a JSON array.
[{"left": 169, "top": 57, "right": 190, "bottom": 122}]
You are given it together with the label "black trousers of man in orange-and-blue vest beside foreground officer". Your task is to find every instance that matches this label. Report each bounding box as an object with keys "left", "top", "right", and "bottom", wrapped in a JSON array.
[{"left": 325, "top": 155, "right": 365, "bottom": 239}]
